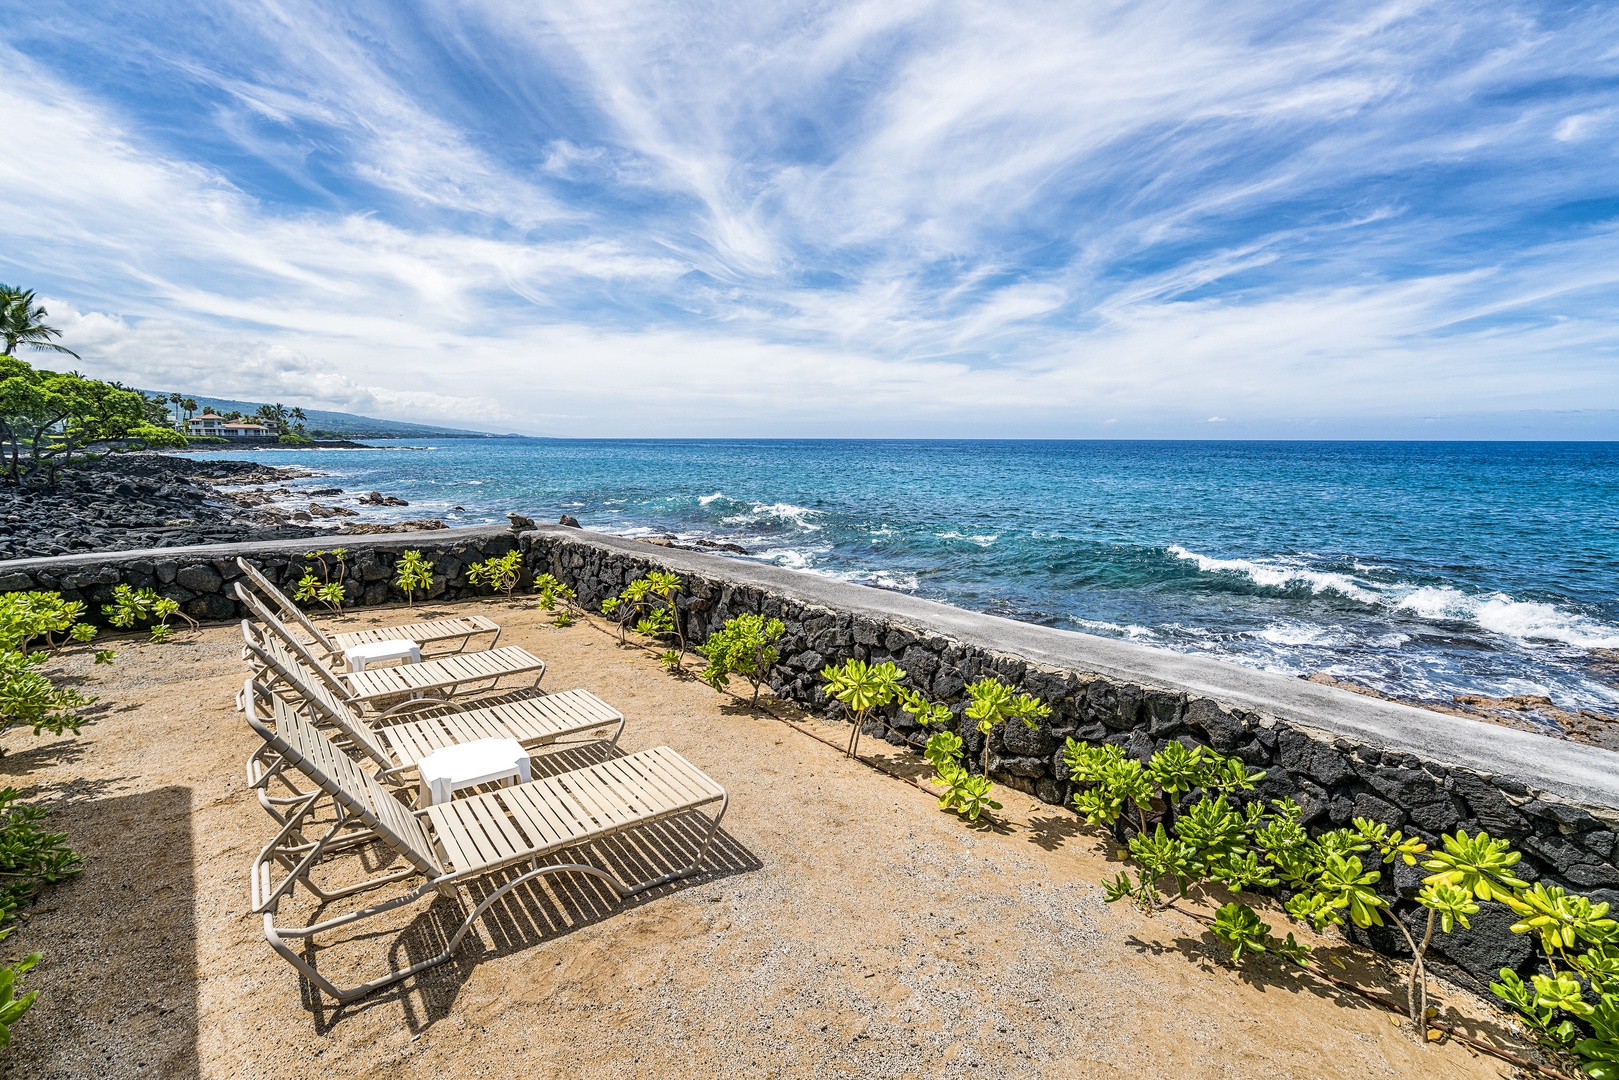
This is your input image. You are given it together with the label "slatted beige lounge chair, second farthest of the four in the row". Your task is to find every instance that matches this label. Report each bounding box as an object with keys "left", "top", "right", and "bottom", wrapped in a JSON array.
[{"left": 236, "top": 581, "right": 546, "bottom": 711}]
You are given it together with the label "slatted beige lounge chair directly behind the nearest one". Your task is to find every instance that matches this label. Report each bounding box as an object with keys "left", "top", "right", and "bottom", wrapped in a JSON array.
[{"left": 246, "top": 627, "right": 625, "bottom": 782}]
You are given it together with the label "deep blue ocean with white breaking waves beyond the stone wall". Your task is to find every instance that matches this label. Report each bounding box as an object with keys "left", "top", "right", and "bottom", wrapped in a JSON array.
[{"left": 202, "top": 439, "right": 1619, "bottom": 712}]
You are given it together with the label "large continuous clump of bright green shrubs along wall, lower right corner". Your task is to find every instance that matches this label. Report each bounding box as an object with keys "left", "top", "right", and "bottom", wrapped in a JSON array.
[{"left": 1064, "top": 738, "right": 1619, "bottom": 1055}]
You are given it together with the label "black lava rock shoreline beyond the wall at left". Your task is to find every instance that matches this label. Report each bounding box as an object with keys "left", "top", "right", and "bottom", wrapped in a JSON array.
[{"left": 0, "top": 453, "right": 445, "bottom": 560}]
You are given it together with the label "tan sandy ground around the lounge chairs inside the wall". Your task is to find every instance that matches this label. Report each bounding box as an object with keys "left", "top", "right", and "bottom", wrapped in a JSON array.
[{"left": 0, "top": 604, "right": 1541, "bottom": 1080}]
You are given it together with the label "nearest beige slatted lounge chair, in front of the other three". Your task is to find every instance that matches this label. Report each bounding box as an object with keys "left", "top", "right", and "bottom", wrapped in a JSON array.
[{"left": 241, "top": 680, "right": 727, "bottom": 1002}]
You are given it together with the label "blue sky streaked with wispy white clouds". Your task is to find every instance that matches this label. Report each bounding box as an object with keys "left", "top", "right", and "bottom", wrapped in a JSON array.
[{"left": 0, "top": 0, "right": 1619, "bottom": 439}]
